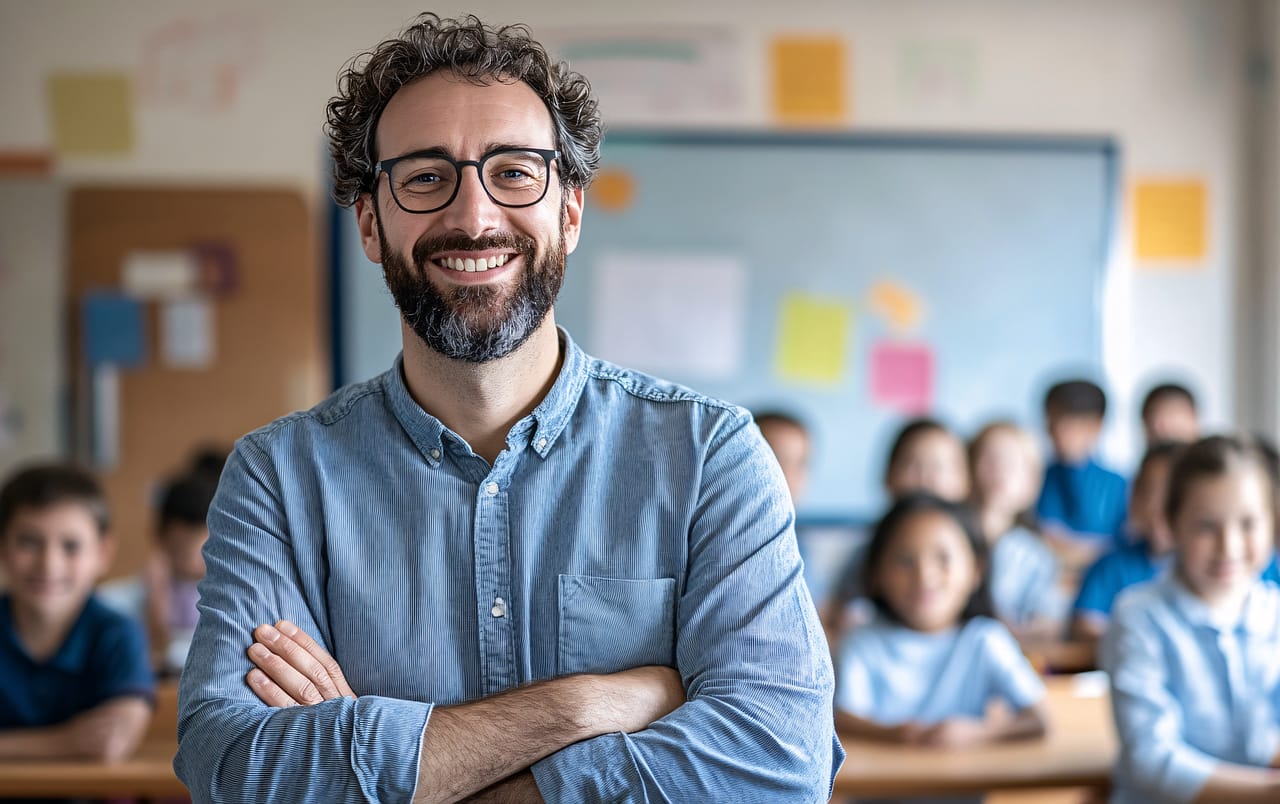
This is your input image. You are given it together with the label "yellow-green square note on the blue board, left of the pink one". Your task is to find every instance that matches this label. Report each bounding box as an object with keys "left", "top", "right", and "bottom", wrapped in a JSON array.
[{"left": 776, "top": 293, "right": 854, "bottom": 384}]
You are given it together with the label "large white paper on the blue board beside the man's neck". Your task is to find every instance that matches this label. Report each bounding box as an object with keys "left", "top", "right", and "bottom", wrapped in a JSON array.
[{"left": 591, "top": 252, "right": 746, "bottom": 380}]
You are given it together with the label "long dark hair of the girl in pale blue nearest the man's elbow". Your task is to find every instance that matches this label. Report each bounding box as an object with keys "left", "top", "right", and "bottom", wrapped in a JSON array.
[{"left": 861, "top": 492, "right": 995, "bottom": 622}]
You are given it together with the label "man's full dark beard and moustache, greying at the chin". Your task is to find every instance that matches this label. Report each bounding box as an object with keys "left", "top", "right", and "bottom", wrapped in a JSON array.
[{"left": 378, "top": 210, "right": 564, "bottom": 364}]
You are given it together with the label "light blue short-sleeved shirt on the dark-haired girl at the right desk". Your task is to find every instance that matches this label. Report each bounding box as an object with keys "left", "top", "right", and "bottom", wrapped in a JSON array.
[{"left": 836, "top": 617, "right": 1044, "bottom": 726}]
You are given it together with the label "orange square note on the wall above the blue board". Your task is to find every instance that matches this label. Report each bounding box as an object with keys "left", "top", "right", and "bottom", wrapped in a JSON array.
[{"left": 772, "top": 36, "right": 847, "bottom": 123}]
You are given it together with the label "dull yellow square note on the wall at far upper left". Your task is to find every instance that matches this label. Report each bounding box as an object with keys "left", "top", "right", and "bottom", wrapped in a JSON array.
[{"left": 47, "top": 73, "right": 133, "bottom": 156}]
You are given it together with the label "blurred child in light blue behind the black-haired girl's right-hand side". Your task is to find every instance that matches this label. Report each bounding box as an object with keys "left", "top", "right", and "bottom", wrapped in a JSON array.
[{"left": 969, "top": 421, "right": 1066, "bottom": 636}]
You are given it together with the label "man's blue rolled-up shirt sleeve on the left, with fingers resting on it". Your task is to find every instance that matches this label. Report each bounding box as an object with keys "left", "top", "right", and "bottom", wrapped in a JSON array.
[{"left": 174, "top": 439, "right": 431, "bottom": 801}]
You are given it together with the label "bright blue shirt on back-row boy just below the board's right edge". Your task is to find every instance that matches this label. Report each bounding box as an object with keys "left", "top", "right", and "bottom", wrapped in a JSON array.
[{"left": 1036, "top": 458, "right": 1129, "bottom": 544}]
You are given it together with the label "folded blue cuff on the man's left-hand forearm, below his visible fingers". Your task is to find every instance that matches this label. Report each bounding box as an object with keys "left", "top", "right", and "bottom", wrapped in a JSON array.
[{"left": 351, "top": 695, "right": 431, "bottom": 801}]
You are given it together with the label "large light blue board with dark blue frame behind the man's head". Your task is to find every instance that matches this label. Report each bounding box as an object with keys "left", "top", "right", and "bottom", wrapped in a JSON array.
[{"left": 334, "top": 132, "right": 1117, "bottom": 517}]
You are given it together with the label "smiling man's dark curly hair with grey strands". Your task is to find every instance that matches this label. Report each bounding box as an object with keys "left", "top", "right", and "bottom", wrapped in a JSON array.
[{"left": 325, "top": 13, "right": 604, "bottom": 206}]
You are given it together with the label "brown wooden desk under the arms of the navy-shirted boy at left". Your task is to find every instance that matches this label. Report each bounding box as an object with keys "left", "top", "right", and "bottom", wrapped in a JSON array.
[{"left": 0, "top": 682, "right": 187, "bottom": 799}]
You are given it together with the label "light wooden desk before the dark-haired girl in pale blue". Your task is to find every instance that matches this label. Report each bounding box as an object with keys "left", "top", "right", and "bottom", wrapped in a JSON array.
[{"left": 836, "top": 675, "right": 1117, "bottom": 796}]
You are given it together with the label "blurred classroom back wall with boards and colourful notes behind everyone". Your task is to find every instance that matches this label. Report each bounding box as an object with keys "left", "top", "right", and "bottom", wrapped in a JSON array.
[{"left": 0, "top": 0, "right": 1280, "bottom": 575}]
